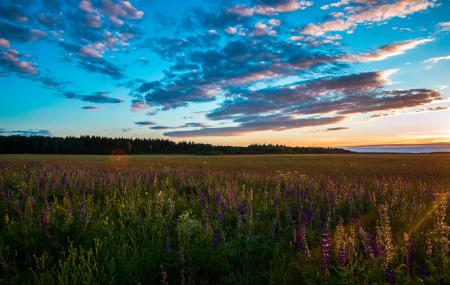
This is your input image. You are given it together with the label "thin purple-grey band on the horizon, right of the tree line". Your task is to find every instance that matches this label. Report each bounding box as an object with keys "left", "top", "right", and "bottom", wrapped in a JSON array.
[{"left": 343, "top": 144, "right": 450, "bottom": 153}]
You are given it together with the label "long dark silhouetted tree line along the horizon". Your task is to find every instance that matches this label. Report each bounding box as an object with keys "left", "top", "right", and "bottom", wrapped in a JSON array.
[{"left": 0, "top": 136, "right": 352, "bottom": 155}]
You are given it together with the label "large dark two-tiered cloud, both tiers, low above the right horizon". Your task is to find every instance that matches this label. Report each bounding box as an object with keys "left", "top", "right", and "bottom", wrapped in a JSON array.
[{"left": 199, "top": 70, "right": 442, "bottom": 136}]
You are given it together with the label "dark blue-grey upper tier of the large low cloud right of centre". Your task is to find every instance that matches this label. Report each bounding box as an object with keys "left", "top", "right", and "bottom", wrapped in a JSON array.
[{"left": 207, "top": 71, "right": 398, "bottom": 120}]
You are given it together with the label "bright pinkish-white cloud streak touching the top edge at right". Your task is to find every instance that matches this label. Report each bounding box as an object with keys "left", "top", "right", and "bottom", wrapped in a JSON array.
[{"left": 301, "top": 0, "right": 436, "bottom": 36}]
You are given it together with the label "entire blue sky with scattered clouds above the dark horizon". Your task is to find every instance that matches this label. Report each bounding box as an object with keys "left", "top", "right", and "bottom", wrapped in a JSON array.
[{"left": 0, "top": 0, "right": 450, "bottom": 152}]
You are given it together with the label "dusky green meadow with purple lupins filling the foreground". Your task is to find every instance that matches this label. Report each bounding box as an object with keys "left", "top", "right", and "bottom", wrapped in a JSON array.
[{"left": 0, "top": 154, "right": 450, "bottom": 284}]
